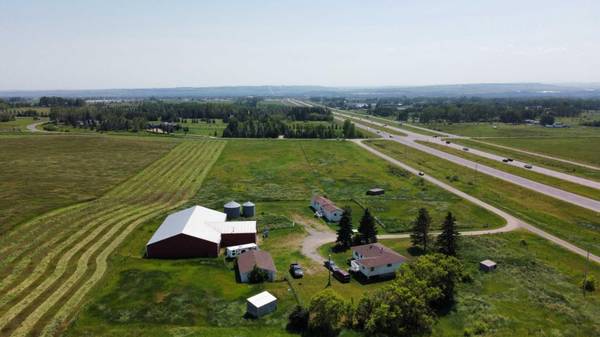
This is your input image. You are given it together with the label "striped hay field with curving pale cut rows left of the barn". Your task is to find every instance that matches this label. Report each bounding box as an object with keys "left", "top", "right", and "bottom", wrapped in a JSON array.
[{"left": 0, "top": 141, "right": 225, "bottom": 336}]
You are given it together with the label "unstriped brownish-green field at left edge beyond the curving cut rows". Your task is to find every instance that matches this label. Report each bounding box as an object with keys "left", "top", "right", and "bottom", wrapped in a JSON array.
[{"left": 0, "top": 135, "right": 177, "bottom": 233}]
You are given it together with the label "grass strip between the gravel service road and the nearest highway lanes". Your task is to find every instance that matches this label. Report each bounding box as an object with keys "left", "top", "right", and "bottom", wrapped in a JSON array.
[{"left": 367, "top": 140, "right": 600, "bottom": 254}]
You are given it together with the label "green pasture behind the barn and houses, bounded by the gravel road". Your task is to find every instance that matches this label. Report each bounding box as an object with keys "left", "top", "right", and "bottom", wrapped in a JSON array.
[{"left": 196, "top": 140, "right": 504, "bottom": 232}]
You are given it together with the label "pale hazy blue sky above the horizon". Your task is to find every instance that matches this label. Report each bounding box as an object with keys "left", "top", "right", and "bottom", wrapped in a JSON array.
[{"left": 0, "top": 0, "right": 600, "bottom": 90}]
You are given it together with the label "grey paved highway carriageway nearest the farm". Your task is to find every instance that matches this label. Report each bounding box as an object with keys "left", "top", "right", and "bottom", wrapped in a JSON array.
[{"left": 334, "top": 111, "right": 600, "bottom": 212}]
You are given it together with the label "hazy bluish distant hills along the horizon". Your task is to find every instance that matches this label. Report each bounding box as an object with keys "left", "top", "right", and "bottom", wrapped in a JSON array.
[{"left": 0, "top": 83, "right": 600, "bottom": 99}]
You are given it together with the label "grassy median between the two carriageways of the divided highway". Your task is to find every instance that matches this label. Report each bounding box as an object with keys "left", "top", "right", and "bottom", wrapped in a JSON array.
[{"left": 418, "top": 141, "right": 600, "bottom": 200}]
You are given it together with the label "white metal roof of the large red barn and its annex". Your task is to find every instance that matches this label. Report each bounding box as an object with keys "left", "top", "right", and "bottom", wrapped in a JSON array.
[{"left": 147, "top": 206, "right": 256, "bottom": 245}]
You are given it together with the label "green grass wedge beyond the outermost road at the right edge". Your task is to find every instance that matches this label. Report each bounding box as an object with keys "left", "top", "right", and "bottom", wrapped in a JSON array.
[{"left": 472, "top": 136, "right": 600, "bottom": 167}]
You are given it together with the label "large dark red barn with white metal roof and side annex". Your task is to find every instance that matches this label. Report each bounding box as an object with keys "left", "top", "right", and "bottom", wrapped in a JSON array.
[{"left": 146, "top": 206, "right": 256, "bottom": 258}]
